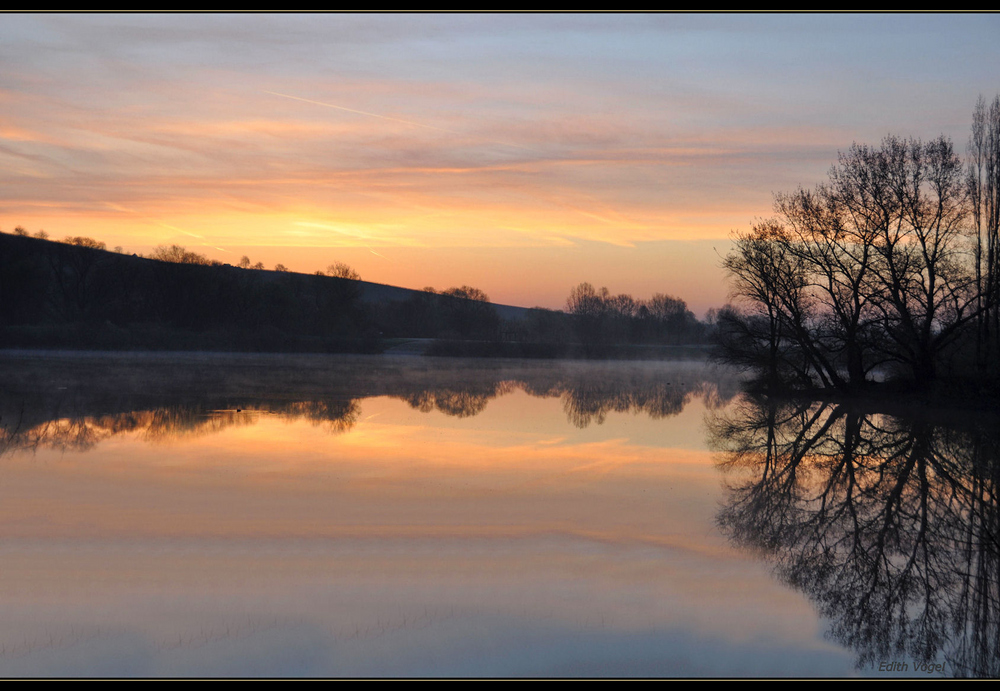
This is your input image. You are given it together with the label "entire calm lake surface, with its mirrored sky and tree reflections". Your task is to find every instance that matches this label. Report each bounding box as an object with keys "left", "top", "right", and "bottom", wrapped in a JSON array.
[{"left": 0, "top": 354, "right": 984, "bottom": 676}]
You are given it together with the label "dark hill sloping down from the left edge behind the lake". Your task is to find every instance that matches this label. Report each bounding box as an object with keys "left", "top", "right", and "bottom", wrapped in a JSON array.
[{"left": 0, "top": 234, "right": 531, "bottom": 352}]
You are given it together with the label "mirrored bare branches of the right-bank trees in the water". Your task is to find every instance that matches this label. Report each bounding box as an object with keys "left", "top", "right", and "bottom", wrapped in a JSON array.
[{"left": 710, "top": 398, "right": 1000, "bottom": 677}]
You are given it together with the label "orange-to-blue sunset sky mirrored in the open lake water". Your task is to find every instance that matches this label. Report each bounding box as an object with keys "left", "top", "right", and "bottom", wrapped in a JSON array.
[{"left": 0, "top": 362, "right": 851, "bottom": 676}]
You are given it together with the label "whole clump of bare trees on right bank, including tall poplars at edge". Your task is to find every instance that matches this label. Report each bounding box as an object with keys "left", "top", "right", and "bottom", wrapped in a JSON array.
[{"left": 718, "top": 97, "right": 1000, "bottom": 392}]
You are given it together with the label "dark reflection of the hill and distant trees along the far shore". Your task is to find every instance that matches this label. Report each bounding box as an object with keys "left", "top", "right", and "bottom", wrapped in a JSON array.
[{"left": 0, "top": 354, "right": 737, "bottom": 454}]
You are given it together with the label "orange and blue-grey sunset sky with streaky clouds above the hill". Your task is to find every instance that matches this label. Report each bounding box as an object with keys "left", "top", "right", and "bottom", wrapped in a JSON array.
[{"left": 0, "top": 14, "right": 1000, "bottom": 316}]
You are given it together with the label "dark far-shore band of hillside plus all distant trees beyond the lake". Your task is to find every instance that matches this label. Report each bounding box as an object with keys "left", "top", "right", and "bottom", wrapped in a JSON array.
[{"left": 0, "top": 232, "right": 707, "bottom": 357}]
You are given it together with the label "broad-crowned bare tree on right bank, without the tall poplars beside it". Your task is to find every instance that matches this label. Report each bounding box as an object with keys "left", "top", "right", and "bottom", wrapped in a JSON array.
[{"left": 722, "top": 130, "right": 981, "bottom": 389}]
